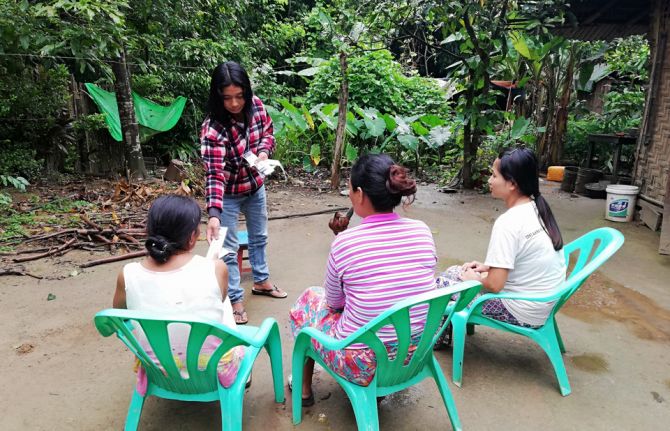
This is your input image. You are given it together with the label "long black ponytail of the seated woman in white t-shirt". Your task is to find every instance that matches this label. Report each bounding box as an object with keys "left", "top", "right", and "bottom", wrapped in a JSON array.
[{"left": 498, "top": 147, "right": 563, "bottom": 250}]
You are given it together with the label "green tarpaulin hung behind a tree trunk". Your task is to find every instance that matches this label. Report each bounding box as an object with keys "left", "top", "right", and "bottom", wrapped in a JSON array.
[{"left": 86, "top": 83, "right": 186, "bottom": 142}]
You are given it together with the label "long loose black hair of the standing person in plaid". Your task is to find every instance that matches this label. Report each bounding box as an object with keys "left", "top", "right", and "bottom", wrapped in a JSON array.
[{"left": 206, "top": 61, "right": 254, "bottom": 129}]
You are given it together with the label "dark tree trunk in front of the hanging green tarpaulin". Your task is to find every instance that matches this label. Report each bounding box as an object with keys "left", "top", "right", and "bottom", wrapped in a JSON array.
[{"left": 112, "top": 50, "right": 147, "bottom": 179}]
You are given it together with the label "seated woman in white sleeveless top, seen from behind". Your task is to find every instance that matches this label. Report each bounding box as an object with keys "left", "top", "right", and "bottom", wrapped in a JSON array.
[{"left": 113, "top": 195, "right": 244, "bottom": 393}]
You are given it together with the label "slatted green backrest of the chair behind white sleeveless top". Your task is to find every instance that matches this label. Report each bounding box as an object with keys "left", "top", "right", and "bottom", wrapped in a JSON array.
[{"left": 94, "top": 309, "right": 253, "bottom": 394}]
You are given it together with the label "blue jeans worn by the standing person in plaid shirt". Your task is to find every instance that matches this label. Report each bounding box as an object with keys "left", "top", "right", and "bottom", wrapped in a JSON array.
[{"left": 219, "top": 186, "right": 270, "bottom": 304}]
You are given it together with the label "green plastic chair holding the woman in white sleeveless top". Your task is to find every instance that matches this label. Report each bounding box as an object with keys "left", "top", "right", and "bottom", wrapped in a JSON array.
[{"left": 94, "top": 309, "right": 284, "bottom": 430}]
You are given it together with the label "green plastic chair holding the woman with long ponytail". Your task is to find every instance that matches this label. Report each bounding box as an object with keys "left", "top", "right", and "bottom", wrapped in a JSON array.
[{"left": 447, "top": 227, "right": 624, "bottom": 396}]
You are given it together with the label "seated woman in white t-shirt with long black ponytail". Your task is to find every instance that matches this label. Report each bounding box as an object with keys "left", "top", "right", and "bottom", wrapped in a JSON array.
[{"left": 437, "top": 148, "right": 566, "bottom": 327}]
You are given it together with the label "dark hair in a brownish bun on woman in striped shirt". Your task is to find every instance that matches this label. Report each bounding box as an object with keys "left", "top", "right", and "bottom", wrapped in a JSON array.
[{"left": 351, "top": 154, "right": 416, "bottom": 212}]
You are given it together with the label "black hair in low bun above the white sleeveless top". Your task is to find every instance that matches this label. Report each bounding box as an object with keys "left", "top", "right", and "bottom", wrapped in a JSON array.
[{"left": 144, "top": 195, "right": 201, "bottom": 263}]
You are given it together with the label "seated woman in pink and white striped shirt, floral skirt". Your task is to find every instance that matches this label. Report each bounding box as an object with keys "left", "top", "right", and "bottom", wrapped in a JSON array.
[{"left": 290, "top": 154, "right": 437, "bottom": 406}]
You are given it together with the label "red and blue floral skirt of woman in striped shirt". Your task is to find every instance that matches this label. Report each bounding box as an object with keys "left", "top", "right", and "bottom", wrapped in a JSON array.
[{"left": 289, "top": 286, "right": 418, "bottom": 386}]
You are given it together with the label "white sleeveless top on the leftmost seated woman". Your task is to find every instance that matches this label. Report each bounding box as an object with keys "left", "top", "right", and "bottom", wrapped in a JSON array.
[{"left": 123, "top": 255, "right": 236, "bottom": 328}]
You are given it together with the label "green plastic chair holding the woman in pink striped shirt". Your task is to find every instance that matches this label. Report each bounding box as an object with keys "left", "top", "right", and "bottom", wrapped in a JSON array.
[{"left": 292, "top": 281, "right": 481, "bottom": 430}]
